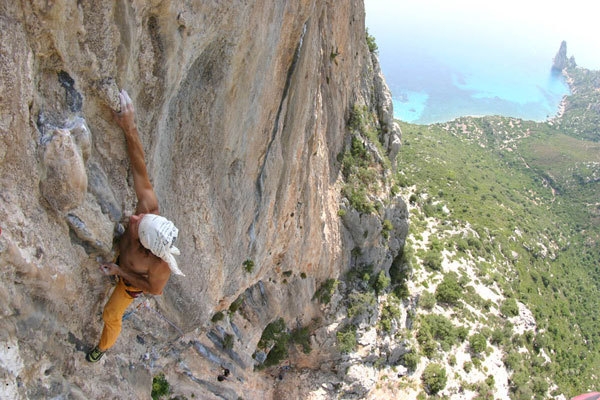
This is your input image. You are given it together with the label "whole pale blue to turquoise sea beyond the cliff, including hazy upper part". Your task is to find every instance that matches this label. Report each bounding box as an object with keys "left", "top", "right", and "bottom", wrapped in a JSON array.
[{"left": 365, "top": 0, "right": 600, "bottom": 124}]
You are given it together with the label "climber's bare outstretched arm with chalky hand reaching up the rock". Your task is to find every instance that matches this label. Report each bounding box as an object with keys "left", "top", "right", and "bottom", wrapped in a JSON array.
[{"left": 114, "top": 90, "right": 158, "bottom": 214}]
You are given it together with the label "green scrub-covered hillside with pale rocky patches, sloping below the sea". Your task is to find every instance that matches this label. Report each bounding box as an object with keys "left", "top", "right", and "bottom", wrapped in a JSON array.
[{"left": 384, "top": 65, "right": 600, "bottom": 399}]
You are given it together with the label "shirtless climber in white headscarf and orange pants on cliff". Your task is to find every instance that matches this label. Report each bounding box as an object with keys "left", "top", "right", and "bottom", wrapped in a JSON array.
[{"left": 85, "top": 90, "right": 183, "bottom": 362}]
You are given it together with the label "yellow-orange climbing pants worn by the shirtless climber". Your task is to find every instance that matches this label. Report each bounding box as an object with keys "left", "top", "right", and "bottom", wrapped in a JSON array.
[{"left": 98, "top": 279, "right": 142, "bottom": 351}]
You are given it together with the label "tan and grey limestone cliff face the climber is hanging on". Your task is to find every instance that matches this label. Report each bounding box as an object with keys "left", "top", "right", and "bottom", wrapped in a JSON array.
[{"left": 0, "top": 0, "right": 406, "bottom": 398}]
